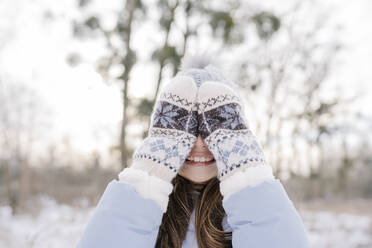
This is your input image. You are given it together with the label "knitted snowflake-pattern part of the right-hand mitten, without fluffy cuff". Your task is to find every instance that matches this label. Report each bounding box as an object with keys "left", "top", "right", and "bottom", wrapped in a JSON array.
[{"left": 198, "top": 81, "right": 266, "bottom": 180}]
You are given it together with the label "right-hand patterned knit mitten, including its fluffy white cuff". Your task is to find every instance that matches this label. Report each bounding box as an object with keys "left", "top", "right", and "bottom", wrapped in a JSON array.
[{"left": 198, "top": 69, "right": 273, "bottom": 199}]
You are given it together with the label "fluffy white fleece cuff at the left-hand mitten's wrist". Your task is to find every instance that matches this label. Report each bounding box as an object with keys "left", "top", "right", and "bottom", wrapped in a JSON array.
[{"left": 118, "top": 167, "right": 173, "bottom": 213}]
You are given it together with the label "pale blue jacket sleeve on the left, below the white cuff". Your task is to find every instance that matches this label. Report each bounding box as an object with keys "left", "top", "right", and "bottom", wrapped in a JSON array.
[{"left": 76, "top": 180, "right": 163, "bottom": 248}]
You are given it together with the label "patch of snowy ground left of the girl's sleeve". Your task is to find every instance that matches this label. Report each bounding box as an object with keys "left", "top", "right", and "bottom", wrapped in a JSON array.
[{"left": 0, "top": 198, "right": 93, "bottom": 248}]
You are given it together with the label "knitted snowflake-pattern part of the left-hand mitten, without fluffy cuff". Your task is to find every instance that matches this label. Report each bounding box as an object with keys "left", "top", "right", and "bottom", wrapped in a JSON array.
[{"left": 132, "top": 76, "right": 198, "bottom": 181}]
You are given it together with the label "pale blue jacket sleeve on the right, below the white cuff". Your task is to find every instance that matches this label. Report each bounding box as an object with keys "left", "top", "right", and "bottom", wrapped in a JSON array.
[{"left": 223, "top": 178, "right": 310, "bottom": 248}]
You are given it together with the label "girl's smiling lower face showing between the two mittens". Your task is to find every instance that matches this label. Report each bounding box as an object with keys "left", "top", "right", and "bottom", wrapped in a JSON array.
[{"left": 178, "top": 135, "right": 217, "bottom": 183}]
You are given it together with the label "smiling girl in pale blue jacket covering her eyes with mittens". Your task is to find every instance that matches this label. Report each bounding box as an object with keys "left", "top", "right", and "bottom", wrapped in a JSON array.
[{"left": 77, "top": 58, "right": 309, "bottom": 248}]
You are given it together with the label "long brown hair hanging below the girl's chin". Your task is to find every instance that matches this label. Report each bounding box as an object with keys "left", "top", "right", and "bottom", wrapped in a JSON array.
[{"left": 155, "top": 174, "right": 232, "bottom": 248}]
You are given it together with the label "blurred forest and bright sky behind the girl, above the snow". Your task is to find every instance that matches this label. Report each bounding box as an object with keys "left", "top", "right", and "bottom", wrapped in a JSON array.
[{"left": 0, "top": 0, "right": 372, "bottom": 247}]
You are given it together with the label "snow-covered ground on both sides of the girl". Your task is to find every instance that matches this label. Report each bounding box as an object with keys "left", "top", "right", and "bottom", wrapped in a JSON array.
[{"left": 0, "top": 198, "right": 372, "bottom": 248}]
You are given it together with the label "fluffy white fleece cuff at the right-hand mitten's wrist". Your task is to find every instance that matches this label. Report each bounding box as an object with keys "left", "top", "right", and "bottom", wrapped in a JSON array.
[{"left": 220, "top": 165, "right": 274, "bottom": 201}]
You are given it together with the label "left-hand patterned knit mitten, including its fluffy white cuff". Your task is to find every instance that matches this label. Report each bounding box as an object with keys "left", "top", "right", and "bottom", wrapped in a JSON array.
[{"left": 119, "top": 75, "right": 198, "bottom": 211}]
